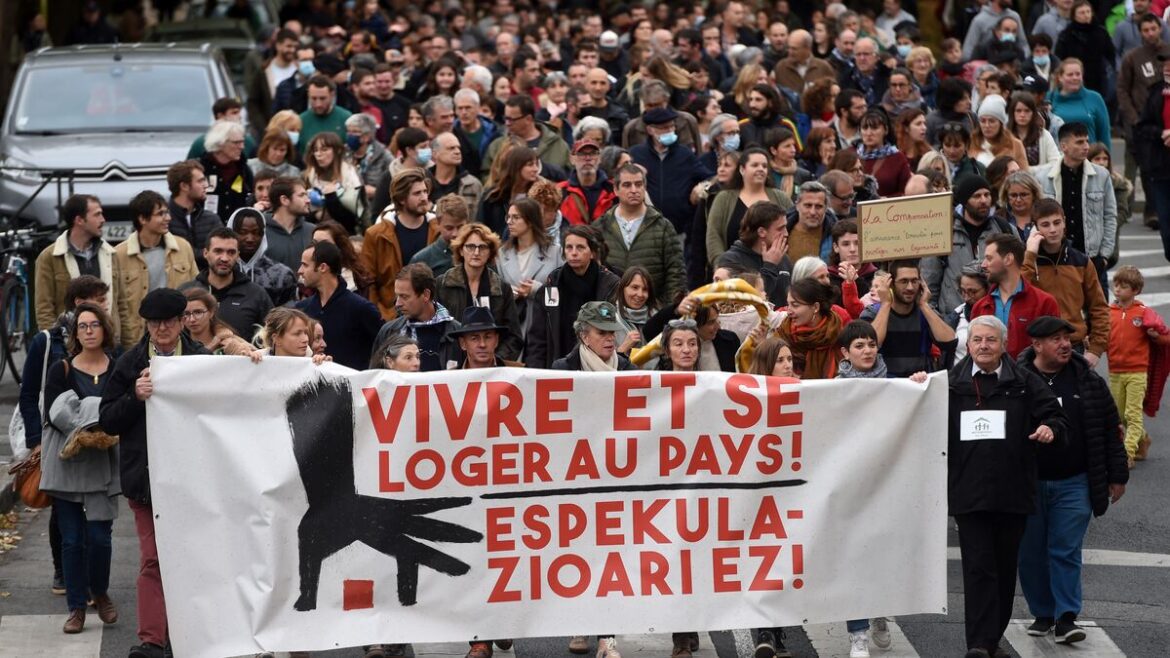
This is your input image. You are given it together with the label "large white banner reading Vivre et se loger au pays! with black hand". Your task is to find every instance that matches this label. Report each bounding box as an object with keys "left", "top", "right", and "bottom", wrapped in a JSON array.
[{"left": 146, "top": 356, "right": 947, "bottom": 658}]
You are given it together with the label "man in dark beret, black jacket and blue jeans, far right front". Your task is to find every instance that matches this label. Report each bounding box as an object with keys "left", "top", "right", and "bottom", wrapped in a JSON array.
[{"left": 1019, "top": 316, "right": 1129, "bottom": 644}]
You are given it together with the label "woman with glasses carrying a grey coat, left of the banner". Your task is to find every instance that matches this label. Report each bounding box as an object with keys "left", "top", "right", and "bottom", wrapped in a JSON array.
[{"left": 41, "top": 302, "right": 122, "bottom": 633}]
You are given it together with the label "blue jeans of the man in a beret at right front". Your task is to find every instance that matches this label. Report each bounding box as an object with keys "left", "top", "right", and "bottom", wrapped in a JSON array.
[{"left": 1019, "top": 473, "right": 1093, "bottom": 618}]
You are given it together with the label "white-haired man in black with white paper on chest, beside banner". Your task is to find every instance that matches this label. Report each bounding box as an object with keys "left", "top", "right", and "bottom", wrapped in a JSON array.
[{"left": 947, "top": 315, "right": 1068, "bottom": 658}]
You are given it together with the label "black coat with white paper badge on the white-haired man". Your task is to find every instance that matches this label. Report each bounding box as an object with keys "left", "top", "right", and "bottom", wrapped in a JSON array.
[{"left": 947, "top": 356, "right": 1068, "bottom": 515}]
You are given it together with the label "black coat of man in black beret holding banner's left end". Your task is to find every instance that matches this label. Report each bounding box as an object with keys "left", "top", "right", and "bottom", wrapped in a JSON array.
[{"left": 98, "top": 333, "right": 211, "bottom": 505}]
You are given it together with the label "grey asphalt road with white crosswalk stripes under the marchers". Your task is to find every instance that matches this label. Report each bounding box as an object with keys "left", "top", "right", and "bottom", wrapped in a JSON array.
[{"left": 0, "top": 216, "right": 1170, "bottom": 658}]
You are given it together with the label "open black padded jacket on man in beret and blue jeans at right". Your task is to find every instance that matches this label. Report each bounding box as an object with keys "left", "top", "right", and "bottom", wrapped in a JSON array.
[{"left": 1017, "top": 348, "right": 1129, "bottom": 516}]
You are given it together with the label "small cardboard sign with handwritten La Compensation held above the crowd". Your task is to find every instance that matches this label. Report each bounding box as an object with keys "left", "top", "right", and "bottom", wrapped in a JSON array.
[{"left": 858, "top": 192, "right": 955, "bottom": 262}]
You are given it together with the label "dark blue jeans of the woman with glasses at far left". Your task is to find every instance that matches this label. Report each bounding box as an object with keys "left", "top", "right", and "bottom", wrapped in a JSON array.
[{"left": 53, "top": 499, "right": 113, "bottom": 610}]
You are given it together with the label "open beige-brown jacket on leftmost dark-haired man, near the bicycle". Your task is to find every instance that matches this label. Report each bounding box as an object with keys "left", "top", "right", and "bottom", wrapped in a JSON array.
[{"left": 35, "top": 231, "right": 122, "bottom": 336}]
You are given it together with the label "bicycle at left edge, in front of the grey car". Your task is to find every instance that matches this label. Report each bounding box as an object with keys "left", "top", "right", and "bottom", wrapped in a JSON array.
[{"left": 0, "top": 228, "right": 43, "bottom": 384}]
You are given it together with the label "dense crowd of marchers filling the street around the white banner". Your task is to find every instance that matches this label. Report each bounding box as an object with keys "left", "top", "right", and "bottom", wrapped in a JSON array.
[{"left": 9, "top": 0, "right": 1170, "bottom": 658}]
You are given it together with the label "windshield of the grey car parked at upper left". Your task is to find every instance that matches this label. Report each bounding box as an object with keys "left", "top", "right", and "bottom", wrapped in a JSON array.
[{"left": 13, "top": 62, "right": 214, "bottom": 133}]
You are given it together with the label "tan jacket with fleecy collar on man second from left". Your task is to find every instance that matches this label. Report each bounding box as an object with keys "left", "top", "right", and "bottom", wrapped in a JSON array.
[{"left": 113, "top": 231, "right": 199, "bottom": 349}]
